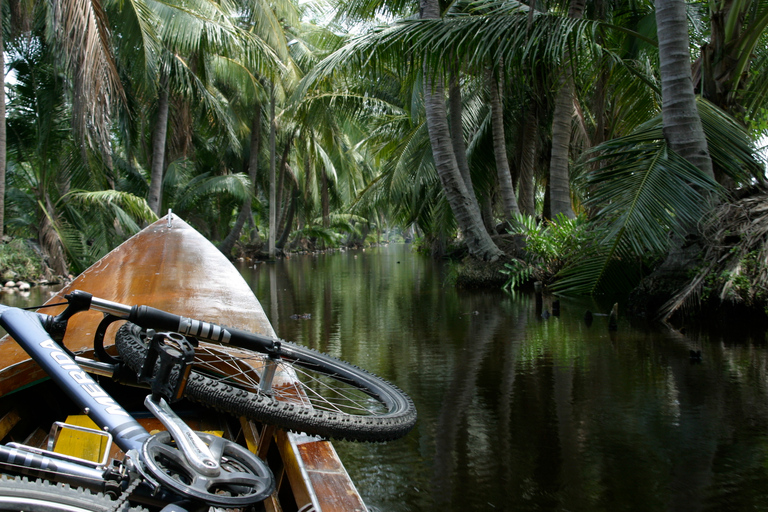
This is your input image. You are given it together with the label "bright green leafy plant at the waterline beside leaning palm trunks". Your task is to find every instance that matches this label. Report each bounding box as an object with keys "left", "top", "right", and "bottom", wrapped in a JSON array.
[{"left": 501, "top": 214, "right": 586, "bottom": 290}]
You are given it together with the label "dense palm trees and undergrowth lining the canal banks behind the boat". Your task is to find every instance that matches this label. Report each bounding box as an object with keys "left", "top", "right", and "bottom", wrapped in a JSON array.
[{"left": 0, "top": 0, "right": 768, "bottom": 320}]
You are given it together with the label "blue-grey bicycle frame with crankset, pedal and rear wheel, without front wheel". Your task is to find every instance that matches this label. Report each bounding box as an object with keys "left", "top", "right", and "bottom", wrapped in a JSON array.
[{"left": 0, "top": 298, "right": 275, "bottom": 512}]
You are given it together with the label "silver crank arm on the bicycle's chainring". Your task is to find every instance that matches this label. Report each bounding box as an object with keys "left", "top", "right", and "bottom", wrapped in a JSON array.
[{"left": 144, "top": 395, "right": 221, "bottom": 476}]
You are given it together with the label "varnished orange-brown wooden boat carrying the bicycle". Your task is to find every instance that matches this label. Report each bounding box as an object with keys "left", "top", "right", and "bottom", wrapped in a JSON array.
[{"left": 0, "top": 214, "right": 366, "bottom": 512}]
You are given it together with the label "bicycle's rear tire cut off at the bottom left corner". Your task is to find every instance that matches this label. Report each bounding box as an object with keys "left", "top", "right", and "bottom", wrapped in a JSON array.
[{"left": 0, "top": 475, "right": 146, "bottom": 512}]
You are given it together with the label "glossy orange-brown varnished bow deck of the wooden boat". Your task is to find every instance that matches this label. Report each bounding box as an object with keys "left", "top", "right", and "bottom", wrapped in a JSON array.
[{"left": 0, "top": 216, "right": 274, "bottom": 396}]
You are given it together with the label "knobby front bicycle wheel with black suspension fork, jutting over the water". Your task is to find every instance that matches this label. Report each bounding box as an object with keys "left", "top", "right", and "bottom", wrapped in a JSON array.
[{"left": 0, "top": 291, "right": 416, "bottom": 488}]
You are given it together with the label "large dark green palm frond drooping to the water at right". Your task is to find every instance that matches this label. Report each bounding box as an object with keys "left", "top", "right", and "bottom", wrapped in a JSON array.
[{"left": 552, "top": 136, "right": 721, "bottom": 295}]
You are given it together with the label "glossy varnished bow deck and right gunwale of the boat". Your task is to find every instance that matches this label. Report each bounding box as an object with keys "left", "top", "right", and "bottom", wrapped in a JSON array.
[{"left": 0, "top": 215, "right": 366, "bottom": 512}]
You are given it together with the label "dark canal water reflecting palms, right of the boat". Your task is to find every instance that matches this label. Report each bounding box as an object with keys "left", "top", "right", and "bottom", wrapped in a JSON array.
[{"left": 241, "top": 245, "right": 768, "bottom": 512}]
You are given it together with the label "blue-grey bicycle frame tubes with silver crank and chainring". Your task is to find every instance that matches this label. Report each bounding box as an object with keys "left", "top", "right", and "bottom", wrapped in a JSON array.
[{"left": 0, "top": 305, "right": 274, "bottom": 508}]
